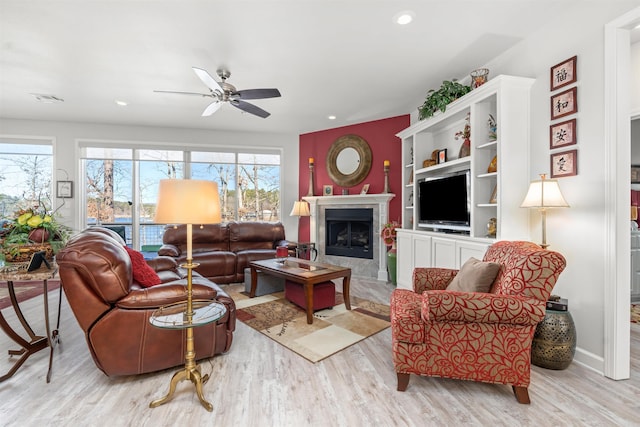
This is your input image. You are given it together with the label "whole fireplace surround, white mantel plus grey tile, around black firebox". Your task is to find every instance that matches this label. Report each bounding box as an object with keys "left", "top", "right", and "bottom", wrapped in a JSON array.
[{"left": 303, "top": 194, "right": 395, "bottom": 281}]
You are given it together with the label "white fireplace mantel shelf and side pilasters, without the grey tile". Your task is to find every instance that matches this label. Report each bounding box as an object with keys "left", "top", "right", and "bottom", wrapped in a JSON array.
[{"left": 302, "top": 193, "right": 395, "bottom": 281}]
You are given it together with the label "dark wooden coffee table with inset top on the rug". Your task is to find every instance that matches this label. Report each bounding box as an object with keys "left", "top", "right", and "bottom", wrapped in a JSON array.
[{"left": 249, "top": 258, "right": 351, "bottom": 324}]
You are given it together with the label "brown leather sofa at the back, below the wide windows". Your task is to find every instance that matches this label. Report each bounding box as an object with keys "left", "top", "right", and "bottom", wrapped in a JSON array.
[{"left": 158, "top": 221, "right": 288, "bottom": 283}]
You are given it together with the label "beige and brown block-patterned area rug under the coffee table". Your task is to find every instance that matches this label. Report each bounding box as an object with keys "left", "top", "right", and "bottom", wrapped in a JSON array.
[{"left": 226, "top": 284, "right": 391, "bottom": 363}]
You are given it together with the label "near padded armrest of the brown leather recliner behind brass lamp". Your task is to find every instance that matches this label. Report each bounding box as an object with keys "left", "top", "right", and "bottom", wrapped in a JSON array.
[{"left": 116, "top": 280, "right": 218, "bottom": 310}]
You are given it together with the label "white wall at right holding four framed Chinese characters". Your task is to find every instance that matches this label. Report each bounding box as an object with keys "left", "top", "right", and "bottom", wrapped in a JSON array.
[{"left": 480, "top": 2, "right": 640, "bottom": 371}]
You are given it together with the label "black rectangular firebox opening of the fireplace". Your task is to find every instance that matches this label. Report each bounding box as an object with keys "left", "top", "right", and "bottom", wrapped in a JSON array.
[{"left": 325, "top": 209, "right": 373, "bottom": 259}]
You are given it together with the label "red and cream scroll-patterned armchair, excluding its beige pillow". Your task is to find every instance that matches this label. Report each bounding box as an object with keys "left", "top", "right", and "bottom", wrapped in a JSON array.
[{"left": 391, "top": 241, "right": 566, "bottom": 403}]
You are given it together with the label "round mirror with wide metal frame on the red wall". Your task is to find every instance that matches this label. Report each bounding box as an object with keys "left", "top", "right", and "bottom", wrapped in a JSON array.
[{"left": 327, "top": 135, "right": 371, "bottom": 187}]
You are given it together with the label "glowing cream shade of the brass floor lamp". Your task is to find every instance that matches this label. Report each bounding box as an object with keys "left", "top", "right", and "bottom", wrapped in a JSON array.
[{"left": 153, "top": 179, "right": 221, "bottom": 224}]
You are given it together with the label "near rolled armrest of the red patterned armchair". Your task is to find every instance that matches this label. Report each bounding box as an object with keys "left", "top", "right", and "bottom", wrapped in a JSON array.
[{"left": 422, "top": 291, "right": 546, "bottom": 326}]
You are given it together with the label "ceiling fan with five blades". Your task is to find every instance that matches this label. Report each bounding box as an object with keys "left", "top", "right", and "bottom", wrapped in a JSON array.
[{"left": 154, "top": 67, "right": 280, "bottom": 119}]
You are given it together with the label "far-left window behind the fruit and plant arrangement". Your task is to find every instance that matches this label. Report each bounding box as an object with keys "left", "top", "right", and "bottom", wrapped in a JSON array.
[{"left": 0, "top": 137, "right": 53, "bottom": 218}]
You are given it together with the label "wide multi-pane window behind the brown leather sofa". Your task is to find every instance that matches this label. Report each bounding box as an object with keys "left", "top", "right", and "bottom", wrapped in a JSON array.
[{"left": 82, "top": 143, "right": 281, "bottom": 251}]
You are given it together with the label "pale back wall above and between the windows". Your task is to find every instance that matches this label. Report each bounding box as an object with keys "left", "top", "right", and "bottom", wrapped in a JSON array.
[{"left": 0, "top": 119, "right": 299, "bottom": 241}]
